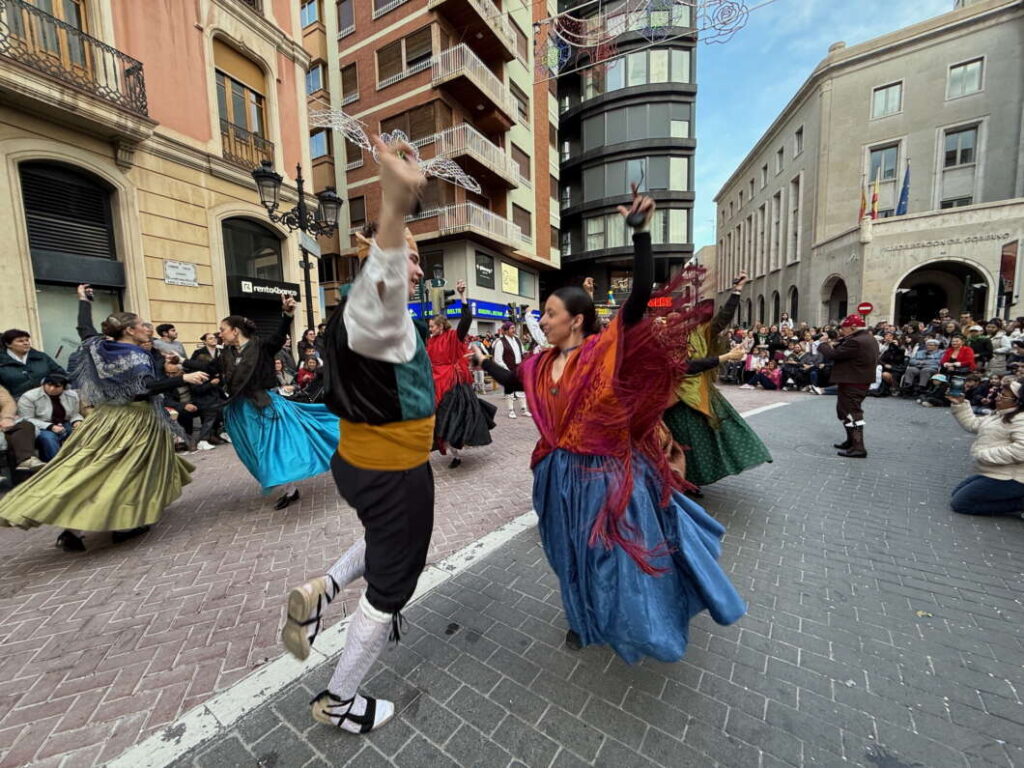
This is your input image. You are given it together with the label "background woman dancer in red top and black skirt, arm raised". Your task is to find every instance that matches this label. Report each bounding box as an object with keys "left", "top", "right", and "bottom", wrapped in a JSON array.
[{"left": 427, "top": 281, "right": 498, "bottom": 469}]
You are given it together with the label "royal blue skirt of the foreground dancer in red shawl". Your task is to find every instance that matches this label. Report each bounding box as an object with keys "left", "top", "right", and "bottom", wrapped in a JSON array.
[{"left": 534, "top": 451, "right": 746, "bottom": 664}]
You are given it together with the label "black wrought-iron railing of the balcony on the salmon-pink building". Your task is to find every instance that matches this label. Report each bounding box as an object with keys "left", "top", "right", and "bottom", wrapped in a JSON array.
[{"left": 0, "top": 0, "right": 148, "bottom": 116}]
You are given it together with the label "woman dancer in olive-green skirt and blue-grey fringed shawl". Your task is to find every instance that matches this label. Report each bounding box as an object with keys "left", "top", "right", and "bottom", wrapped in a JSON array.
[{"left": 0, "top": 285, "right": 208, "bottom": 552}]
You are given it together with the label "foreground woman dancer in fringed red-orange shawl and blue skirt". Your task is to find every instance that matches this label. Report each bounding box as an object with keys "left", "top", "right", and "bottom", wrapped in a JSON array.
[{"left": 475, "top": 188, "right": 745, "bottom": 664}]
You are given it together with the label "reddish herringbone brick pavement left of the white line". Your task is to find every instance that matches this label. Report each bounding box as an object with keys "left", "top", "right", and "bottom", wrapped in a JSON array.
[{"left": 0, "top": 388, "right": 785, "bottom": 768}]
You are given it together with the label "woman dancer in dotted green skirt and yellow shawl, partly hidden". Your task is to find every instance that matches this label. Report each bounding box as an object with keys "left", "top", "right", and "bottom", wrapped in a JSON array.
[{"left": 664, "top": 272, "right": 771, "bottom": 496}]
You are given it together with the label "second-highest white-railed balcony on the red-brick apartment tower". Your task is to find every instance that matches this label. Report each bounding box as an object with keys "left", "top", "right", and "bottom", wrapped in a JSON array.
[{"left": 430, "top": 43, "right": 517, "bottom": 132}]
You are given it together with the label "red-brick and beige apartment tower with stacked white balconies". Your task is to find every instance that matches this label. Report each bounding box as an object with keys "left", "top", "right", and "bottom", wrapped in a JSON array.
[{"left": 300, "top": 0, "right": 560, "bottom": 333}]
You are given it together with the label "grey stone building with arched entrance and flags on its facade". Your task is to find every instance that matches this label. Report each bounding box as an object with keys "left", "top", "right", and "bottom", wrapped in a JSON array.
[{"left": 715, "top": 0, "right": 1024, "bottom": 325}]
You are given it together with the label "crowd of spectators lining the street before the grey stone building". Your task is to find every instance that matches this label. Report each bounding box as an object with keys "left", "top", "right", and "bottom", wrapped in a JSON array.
[{"left": 721, "top": 309, "right": 1024, "bottom": 415}]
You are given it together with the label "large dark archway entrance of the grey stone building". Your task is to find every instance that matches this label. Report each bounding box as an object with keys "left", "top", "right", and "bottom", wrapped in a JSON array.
[{"left": 896, "top": 261, "right": 989, "bottom": 325}]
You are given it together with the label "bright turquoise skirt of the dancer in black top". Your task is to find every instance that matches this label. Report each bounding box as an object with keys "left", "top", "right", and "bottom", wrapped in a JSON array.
[{"left": 224, "top": 392, "right": 339, "bottom": 494}]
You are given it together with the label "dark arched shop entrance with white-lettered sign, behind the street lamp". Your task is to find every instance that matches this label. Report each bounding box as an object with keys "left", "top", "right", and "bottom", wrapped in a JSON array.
[{"left": 221, "top": 217, "right": 294, "bottom": 335}]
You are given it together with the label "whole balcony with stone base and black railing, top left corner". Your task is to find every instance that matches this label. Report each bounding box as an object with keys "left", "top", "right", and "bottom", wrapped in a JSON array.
[{"left": 0, "top": 0, "right": 155, "bottom": 140}]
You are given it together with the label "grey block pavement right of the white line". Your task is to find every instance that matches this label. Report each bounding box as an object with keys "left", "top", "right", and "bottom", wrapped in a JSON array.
[{"left": 159, "top": 397, "right": 1024, "bottom": 768}]
